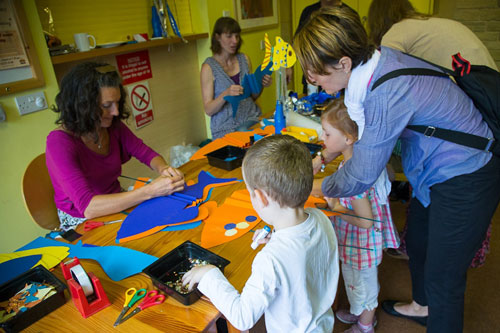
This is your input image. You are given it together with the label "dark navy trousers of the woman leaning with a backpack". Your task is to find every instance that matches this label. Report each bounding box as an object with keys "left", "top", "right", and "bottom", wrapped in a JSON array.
[{"left": 406, "top": 156, "right": 500, "bottom": 333}]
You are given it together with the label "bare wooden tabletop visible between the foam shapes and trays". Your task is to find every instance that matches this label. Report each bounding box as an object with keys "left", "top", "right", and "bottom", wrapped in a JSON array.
[{"left": 25, "top": 159, "right": 263, "bottom": 332}]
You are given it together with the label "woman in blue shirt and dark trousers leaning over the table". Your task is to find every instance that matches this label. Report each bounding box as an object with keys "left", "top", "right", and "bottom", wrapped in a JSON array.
[{"left": 294, "top": 8, "right": 500, "bottom": 333}]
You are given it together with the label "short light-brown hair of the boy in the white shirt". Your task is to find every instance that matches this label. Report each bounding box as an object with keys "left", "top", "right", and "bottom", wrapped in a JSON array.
[{"left": 243, "top": 135, "right": 313, "bottom": 208}]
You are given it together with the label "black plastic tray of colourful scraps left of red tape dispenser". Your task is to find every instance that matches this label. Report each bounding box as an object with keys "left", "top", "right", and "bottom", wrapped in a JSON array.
[{"left": 0, "top": 265, "right": 67, "bottom": 332}]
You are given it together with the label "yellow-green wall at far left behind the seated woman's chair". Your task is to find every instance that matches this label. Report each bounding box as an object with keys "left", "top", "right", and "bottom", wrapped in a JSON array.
[{"left": 0, "top": 0, "right": 58, "bottom": 253}]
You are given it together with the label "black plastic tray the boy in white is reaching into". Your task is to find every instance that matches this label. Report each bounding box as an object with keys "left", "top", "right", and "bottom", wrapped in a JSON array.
[{"left": 143, "top": 241, "right": 229, "bottom": 305}]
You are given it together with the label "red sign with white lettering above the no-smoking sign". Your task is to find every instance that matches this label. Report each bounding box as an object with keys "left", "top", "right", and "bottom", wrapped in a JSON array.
[{"left": 116, "top": 50, "right": 153, "bottom": 85}]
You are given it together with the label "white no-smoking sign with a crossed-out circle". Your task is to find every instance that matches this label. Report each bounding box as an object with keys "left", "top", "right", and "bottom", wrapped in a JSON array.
[{"left": 127, "top": 81, "right": 154, "bottom": 129}]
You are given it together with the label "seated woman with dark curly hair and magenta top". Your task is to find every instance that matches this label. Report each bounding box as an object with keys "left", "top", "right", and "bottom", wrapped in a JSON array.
[{"left": 45, "top": 62, "right": 184, "bottom": 230}]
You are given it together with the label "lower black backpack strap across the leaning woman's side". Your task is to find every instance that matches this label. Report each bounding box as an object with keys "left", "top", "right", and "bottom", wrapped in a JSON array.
[{"left": 406, "top": 125, "right": 497, "bottom": 152}]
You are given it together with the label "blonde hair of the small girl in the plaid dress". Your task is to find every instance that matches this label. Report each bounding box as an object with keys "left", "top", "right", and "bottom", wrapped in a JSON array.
[{"left": 321, "top": 97, "right": 358, "bottom": 141}]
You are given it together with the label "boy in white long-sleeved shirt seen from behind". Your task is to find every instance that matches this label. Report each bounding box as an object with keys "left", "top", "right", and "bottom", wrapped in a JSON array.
[{"left": 183, "top": 135, "right": 339, "bottom": 333}]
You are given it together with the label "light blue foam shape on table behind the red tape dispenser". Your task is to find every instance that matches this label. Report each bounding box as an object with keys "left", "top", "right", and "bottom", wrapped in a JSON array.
[{"left": 17, "top": 237, "right": 158, "bottom": 281}]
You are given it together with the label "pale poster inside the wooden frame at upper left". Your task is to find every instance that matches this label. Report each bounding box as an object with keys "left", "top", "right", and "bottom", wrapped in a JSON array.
[{"left": 0, "top": 0, "right": 30, "bottom": 70}]
